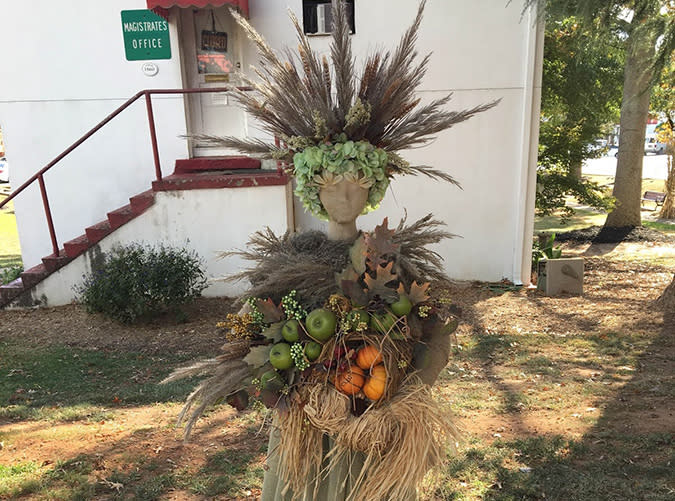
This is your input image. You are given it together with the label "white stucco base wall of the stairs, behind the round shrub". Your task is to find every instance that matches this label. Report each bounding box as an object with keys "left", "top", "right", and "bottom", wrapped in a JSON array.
[{"left": 15, "top": 186, "right": 292, "bottom": 306}]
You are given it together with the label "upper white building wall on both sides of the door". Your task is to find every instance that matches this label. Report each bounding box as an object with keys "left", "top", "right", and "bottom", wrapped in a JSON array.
[{"left": 0, "top": 0, "right": 543, "bottom": 292}]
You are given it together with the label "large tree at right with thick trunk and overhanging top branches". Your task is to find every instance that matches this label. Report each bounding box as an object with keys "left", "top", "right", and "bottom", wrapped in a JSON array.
[{"left": 525, "top": 0, "right": 675, "bottom": 229}]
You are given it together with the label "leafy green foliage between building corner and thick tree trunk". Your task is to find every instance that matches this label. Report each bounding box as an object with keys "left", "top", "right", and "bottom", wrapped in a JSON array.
[{"left": 536, "top": 16, "right": 623, "bottom": 218}]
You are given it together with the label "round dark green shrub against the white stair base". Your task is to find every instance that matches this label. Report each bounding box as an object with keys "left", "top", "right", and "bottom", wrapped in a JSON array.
[{"left": 77, "top": 244, "right": 206, "bottom": 323}]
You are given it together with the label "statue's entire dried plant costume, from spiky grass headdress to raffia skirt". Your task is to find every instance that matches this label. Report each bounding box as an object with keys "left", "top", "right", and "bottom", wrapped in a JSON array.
[{"left": 166, "top": 0, "right": 497, "bottom": 500}]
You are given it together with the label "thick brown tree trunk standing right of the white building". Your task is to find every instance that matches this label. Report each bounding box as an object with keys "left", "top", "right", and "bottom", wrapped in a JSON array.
[{"left": 605, "top": 28, "right": 654, "bottom": 228}]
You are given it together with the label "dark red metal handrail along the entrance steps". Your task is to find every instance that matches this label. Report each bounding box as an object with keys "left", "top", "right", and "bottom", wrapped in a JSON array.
[{"left": 0, "top": 87, "right": 252, "bottom": 257}]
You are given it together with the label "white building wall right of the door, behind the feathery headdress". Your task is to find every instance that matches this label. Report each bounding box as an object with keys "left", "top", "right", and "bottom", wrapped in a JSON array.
[{"left": 246, "top": 0, "right": 543, "bottom": 283}]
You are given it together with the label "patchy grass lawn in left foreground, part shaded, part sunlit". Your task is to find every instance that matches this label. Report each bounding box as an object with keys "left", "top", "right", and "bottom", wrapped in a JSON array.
[{"left": 0, "top": 340, "right": 265, "bottom": 500}]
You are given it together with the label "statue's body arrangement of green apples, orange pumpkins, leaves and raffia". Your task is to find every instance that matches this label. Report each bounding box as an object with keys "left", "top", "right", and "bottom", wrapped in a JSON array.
[{"left": 166, "top": 216, "right": 457, "bottom": 499}]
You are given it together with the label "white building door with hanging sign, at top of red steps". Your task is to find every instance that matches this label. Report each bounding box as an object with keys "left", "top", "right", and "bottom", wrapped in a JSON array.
[{"left": 180, "top": 6, "right": 247, "bottom": 157}]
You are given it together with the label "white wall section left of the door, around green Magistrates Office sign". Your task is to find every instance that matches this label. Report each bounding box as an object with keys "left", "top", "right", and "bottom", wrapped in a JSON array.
[{"left": 0, "top": 0, "right": 187, "bottom": 267}]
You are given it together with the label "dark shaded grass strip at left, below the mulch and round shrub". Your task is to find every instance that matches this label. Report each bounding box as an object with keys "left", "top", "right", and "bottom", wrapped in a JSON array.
[{"left": 0, "top": 341, "right": 211, "bottom": 422}]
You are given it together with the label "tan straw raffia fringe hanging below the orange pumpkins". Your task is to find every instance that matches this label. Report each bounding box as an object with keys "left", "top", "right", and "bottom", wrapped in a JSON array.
[{"left": 279, "top": 378, "right": 458, "bottom": 501}]
